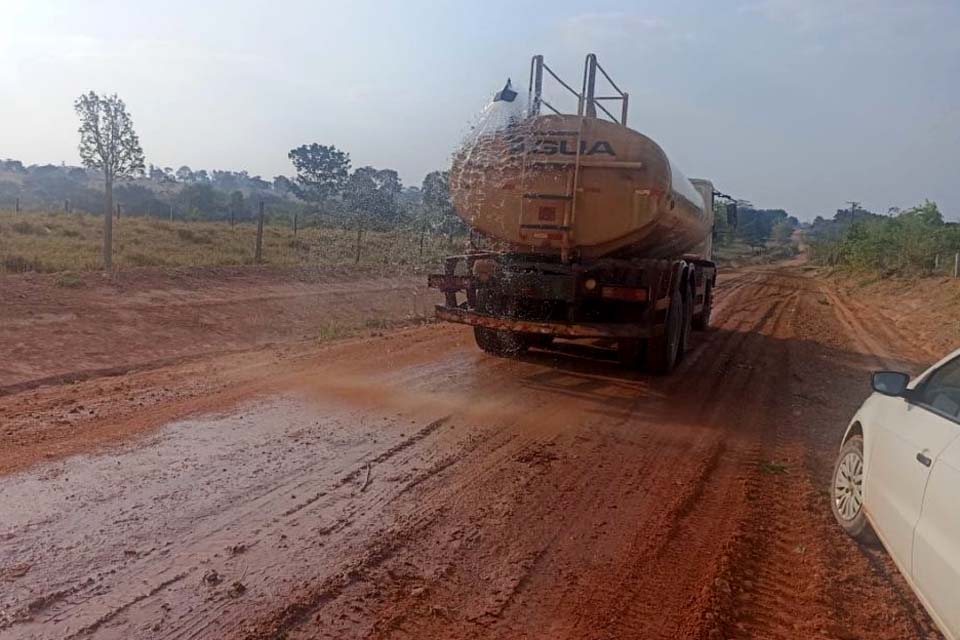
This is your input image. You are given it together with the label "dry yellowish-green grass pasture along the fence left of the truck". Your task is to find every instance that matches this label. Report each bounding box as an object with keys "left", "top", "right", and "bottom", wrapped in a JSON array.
[{"left": 0, "top": 212, "right": 463, "bottom": 274}]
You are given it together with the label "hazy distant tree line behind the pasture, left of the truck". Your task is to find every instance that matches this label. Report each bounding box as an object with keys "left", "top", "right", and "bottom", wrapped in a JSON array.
[{"left": 0, "top": 154, "right": 458, "bottom": 233}]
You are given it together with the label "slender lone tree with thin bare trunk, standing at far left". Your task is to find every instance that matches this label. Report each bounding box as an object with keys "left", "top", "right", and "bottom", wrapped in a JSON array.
[{"left": 73, "top": 91, "right": 143, "bottom": 269}]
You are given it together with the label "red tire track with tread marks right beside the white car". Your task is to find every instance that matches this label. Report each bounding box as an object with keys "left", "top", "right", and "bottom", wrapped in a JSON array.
[{"left": 692, "top": 268, "right": 936, "bottom": 640}]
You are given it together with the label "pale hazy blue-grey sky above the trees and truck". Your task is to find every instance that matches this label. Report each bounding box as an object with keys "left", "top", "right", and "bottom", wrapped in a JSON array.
[{"left": 0, "top": 0, "right": 960, "bottom": 220}]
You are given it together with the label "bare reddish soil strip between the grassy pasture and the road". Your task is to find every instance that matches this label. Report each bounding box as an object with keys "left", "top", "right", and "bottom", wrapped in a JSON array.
[{"left": 0, "top": 267, "right": 434, "bottom": 394}]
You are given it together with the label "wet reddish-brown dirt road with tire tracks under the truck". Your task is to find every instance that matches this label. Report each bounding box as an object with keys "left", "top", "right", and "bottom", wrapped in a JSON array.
[{"left": 0, "top": 267, "right": 939, "bottom": 640}]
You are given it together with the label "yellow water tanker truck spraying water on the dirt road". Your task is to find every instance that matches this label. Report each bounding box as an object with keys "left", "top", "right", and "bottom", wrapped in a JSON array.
[{"left": 428, "top": 54, "right": 735, "bottom": 374}]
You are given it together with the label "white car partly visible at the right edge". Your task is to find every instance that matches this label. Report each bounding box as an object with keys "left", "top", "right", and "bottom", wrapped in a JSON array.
[{"left": 830, "top": 350, "right": 960, "bottom": 640}]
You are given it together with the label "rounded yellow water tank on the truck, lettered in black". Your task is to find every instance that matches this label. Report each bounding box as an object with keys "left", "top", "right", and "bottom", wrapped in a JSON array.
[{"left": 450, "top": 115, "right": 713, "bottom": 258}]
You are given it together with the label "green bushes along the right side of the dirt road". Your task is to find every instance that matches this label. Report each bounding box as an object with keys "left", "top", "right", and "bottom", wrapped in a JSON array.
[{"left": 805, "top": 201, "right": 960, "bottom": 278}]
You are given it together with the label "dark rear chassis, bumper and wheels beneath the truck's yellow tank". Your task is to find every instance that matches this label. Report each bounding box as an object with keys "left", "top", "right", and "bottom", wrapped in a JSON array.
[{"left": 428, "top": 252, "right": 717, "bottom": 373}]
